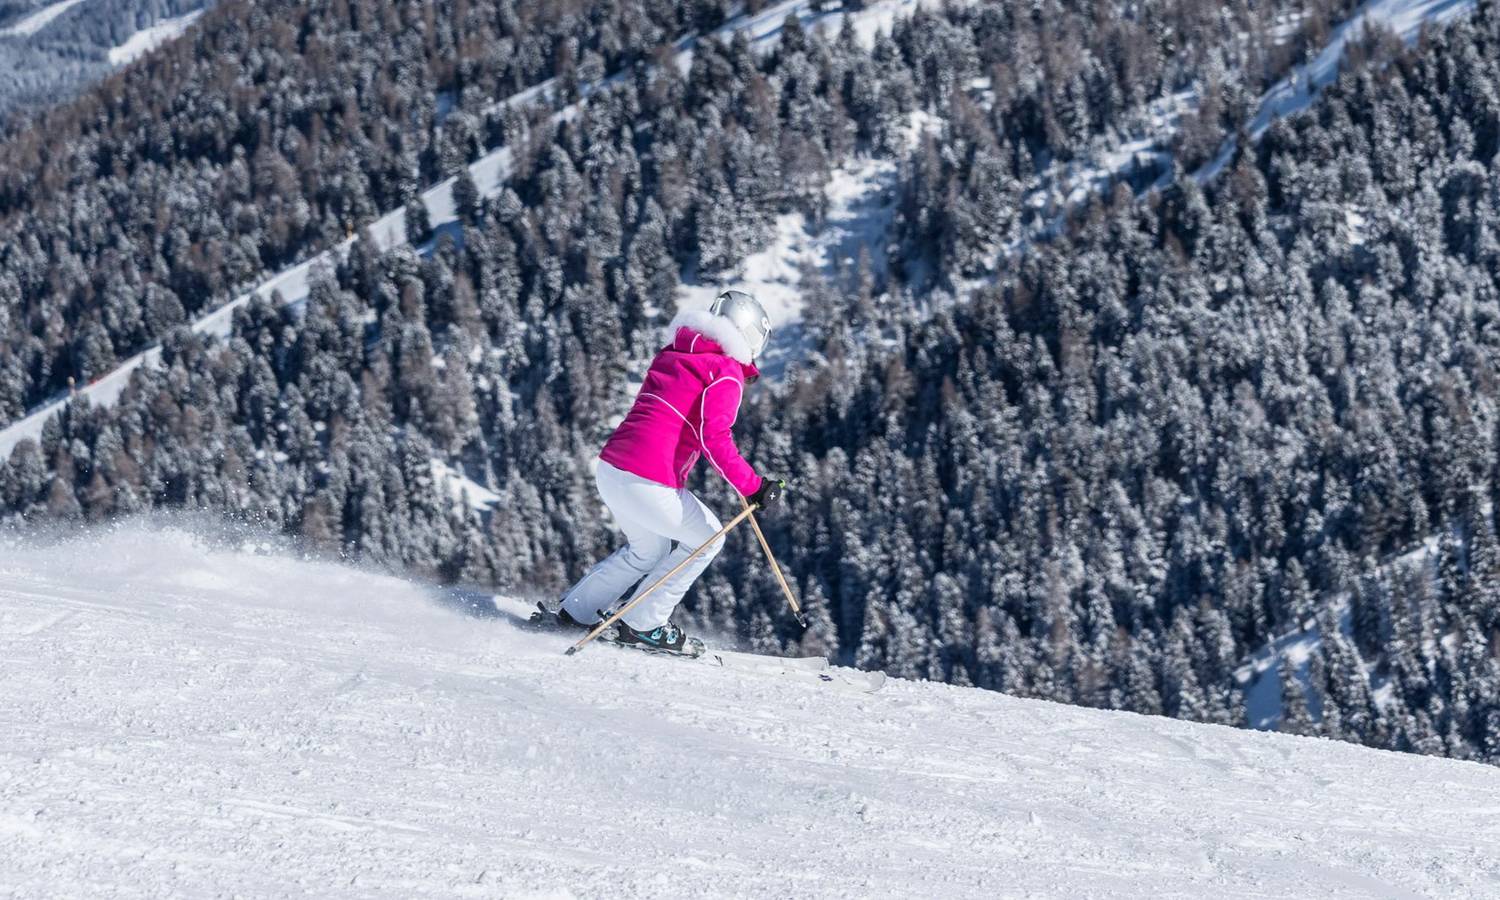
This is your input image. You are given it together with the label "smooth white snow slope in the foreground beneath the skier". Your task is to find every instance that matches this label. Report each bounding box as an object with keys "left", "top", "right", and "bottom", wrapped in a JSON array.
[{"left": 0, "top": 525, "right": 1500, "bottom": 897}]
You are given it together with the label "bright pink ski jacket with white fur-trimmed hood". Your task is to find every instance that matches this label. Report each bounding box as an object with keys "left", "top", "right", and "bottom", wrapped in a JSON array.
[{"left": 599, "top": 311, "right": 761, "bottom": 497}]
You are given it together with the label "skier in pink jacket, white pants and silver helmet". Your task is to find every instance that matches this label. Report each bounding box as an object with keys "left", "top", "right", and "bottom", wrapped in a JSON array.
[{"left": 537, "top": 291, "right": 786, "bottom": 653}]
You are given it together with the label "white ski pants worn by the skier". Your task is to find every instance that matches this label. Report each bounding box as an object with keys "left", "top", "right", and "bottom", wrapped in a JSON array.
[{"left": 563, "top": 461, "right": 725, "bottom": 632}]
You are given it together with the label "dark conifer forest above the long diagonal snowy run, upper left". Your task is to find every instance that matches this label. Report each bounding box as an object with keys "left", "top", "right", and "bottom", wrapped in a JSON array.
[{"left": 0, "top": 0, "right": 741, "bottom": 420}]
